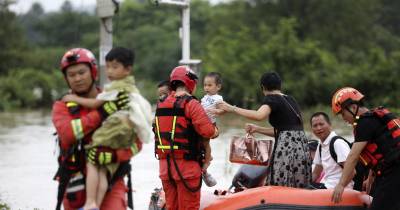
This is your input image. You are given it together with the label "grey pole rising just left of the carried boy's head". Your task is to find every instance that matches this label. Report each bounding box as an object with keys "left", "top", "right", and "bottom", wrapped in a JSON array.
[{"left": 99, "top": 17, "right": 112, "bottom": 88}]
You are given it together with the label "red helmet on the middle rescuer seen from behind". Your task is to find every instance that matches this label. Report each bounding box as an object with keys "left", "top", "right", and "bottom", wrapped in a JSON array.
[{"left": 169, "top": 66, "right": 198, "bottom": 93}]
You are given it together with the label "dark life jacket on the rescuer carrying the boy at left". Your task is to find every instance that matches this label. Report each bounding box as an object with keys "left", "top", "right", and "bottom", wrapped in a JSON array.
[{"left": 53, "top": 102, "right": 135, "bottom": 210}]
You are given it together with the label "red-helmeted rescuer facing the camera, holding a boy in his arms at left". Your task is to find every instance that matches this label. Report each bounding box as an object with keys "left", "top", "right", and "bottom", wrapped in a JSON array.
[{"left": 52, "top": 48, "right": 137, "bottom": 210}]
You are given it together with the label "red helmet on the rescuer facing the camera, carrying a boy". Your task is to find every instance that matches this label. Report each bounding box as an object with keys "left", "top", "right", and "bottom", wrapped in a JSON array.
[{"left": 60, "top": 48, "right": 97, "bottom": 79}]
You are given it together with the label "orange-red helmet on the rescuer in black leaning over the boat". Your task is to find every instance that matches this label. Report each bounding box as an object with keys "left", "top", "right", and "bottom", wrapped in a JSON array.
[{"left": 332, "top": 87, "right": 364, "bottom": 114}]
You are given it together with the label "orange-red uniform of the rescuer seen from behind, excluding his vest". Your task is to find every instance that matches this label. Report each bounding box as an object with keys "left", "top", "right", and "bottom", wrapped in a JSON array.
[{"left": 155, "top": 92, "right": 216, "bottom": 210}]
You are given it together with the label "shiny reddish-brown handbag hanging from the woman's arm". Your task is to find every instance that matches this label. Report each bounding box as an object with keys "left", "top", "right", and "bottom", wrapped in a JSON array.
[{"left": 229, "top": 134, "right": 273, "bottom": 166}]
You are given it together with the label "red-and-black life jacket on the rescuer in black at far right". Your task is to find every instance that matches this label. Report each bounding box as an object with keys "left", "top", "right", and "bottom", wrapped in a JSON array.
[{"left": 360, "top": 107, "right": 400, "bottom": 176}]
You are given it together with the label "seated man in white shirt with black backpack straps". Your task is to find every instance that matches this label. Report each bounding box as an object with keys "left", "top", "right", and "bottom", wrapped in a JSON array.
[{"left": 310, "top": 112, "right": 354, "bottom": 189}]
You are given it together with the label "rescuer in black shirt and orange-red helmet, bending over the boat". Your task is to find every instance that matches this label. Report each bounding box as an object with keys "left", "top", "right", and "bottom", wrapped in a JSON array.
[{"left": 332, "top": 87, "right": 400, "bottom": 210}]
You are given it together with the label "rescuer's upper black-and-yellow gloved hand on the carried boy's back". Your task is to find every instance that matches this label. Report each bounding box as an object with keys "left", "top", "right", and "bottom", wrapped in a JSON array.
[{"left": 99, "top": 90, "right": 130, "bottom": 119}]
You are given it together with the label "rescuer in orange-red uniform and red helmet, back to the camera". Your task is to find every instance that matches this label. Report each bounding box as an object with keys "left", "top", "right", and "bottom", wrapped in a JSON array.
[{"left": 154, "top": 66, "right": 218, "bottom": 210}]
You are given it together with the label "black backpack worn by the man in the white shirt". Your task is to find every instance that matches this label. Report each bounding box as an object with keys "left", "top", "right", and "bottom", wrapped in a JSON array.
[{"left": 319, "top": 136, "right": 368, "bottom": 191}]
